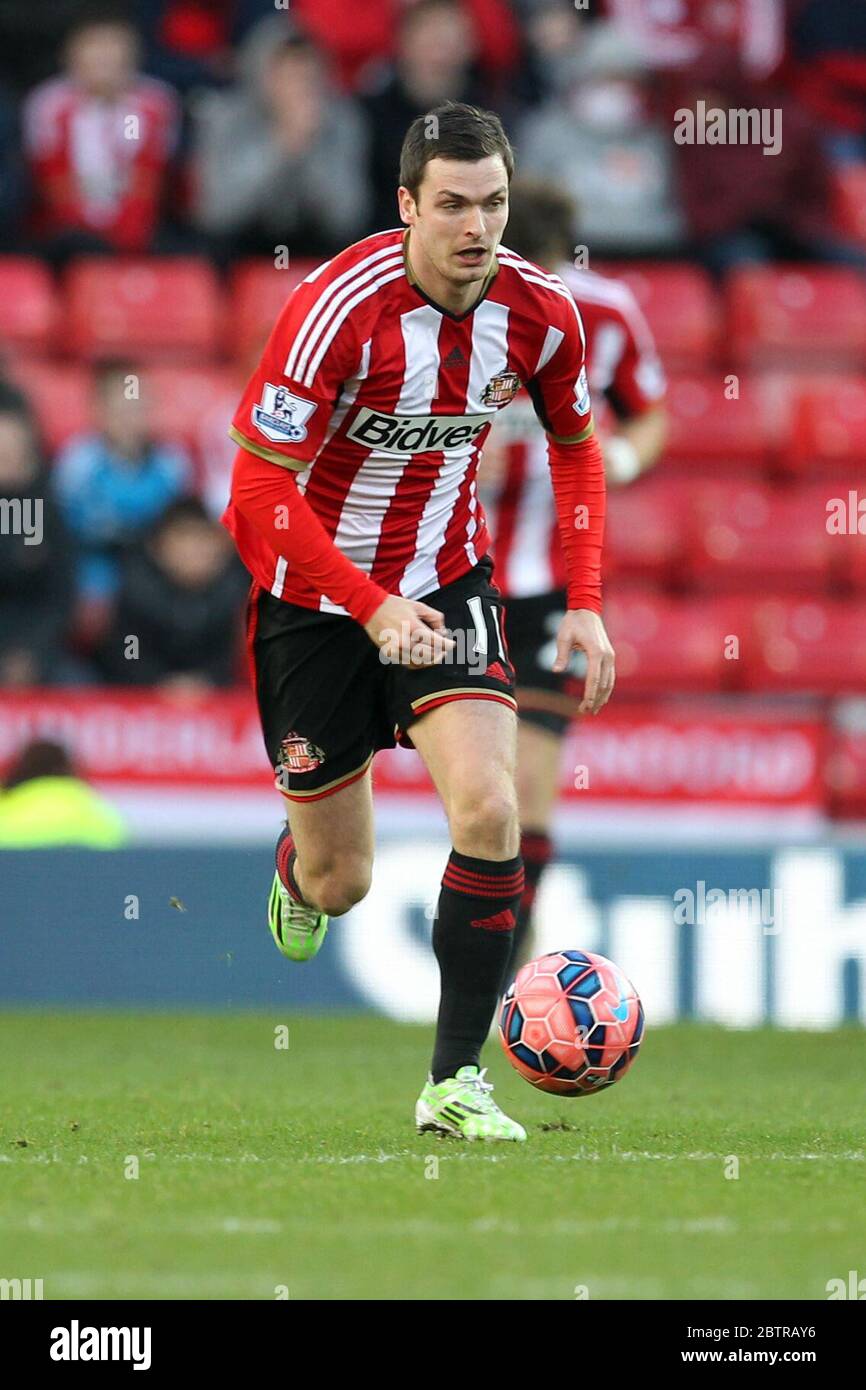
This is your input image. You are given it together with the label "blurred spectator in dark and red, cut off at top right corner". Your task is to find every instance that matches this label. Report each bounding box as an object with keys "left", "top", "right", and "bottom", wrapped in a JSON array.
[{"left": 792, "top": 0, "right": 866, "bottom": 164}]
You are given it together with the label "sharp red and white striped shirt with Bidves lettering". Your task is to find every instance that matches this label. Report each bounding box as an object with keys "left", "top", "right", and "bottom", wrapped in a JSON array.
[{"left": 224, "top": 229, "right": 592, "bottom": 613}]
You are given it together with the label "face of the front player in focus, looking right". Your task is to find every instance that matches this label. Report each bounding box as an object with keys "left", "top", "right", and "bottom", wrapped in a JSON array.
[{"left": 400, "top": 154, "right": 509, "bottom": 289}]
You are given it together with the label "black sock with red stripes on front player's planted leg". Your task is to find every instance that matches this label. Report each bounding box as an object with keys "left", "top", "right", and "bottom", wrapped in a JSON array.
[{"left": 431, "top": 849, "right": 523, "bottom": 1083}]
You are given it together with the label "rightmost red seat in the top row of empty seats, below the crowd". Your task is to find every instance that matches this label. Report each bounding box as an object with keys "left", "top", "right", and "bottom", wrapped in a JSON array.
[{"left": 727, "top": 265, "right": 866, "bottom": 370}]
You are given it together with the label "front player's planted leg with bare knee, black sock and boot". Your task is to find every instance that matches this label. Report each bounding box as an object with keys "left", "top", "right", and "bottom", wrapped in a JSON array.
[{"left": 411, "top": 699, "right": 525, "bottom": 1140}]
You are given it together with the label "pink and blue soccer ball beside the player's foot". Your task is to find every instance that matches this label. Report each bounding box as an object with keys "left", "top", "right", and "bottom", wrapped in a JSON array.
[{"left": 499, "top": 951, "right": 644, "bottom": 1095}]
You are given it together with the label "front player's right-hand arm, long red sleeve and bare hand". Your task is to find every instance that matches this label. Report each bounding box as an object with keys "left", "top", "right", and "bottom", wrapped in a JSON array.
[{"left": 530, "top": 299, "right": 614, "bottom": 714}]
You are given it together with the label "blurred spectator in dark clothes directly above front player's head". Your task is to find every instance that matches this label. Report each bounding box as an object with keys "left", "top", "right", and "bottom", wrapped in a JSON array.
[{"left": 364, "top": 0, "right": 482, "bottom": 231}]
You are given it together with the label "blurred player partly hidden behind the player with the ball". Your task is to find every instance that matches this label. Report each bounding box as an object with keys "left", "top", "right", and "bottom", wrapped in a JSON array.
[{"left": 481, "top": 179, "right": 667, "bottom": 973}]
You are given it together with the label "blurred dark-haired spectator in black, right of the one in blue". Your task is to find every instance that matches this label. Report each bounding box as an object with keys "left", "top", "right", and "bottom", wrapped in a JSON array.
[{"left": 96, "top": 499, "right": 249, "bottom": 694}]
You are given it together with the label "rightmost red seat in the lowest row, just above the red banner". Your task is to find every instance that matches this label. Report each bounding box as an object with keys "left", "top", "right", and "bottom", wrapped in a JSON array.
[{"left": 744, "top": 598, "right": 866, "bottom": 695}]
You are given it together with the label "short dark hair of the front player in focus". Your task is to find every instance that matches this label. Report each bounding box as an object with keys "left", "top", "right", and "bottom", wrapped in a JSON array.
[{"left": 400, "top": 101, "right": 514, "bottom": 199}]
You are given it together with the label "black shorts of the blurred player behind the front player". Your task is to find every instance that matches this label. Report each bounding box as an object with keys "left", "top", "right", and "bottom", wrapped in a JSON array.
[{"left": 507, "top": 589, "right": 587, "bottom": 735}]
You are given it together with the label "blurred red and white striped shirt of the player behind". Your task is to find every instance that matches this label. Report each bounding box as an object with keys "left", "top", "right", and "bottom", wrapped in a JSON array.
[{"left": 481, "top": 265, "right": 666, "bottom": 598}]
